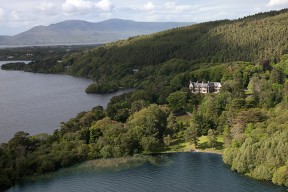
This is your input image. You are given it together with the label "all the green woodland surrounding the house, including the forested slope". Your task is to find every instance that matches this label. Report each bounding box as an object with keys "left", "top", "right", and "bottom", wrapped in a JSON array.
[{"left": 0, "top": 10, "right": 288, "bottom": 188}]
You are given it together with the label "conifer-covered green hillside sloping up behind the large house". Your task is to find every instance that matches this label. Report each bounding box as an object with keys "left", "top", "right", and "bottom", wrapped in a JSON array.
[{"left": 59, "top": 10, "right": 288, "bottom": 81}]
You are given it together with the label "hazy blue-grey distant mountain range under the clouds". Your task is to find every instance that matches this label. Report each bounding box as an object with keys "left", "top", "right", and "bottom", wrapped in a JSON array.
[{"left": 0, "top": 19, "right": 193, "bottom": 46}]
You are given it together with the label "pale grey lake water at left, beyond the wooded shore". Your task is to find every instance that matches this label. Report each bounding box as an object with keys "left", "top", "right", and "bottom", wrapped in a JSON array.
[{"left": 0, "top": 61, "right": 128, "bottom": 143}]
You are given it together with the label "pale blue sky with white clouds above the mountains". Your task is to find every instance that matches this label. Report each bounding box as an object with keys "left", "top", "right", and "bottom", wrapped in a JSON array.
[{"left": 0, "top": 0, "right": 288, "bottom": 35}]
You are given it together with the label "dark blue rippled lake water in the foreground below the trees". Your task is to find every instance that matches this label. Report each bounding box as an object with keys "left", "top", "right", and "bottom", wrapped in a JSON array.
[{"left": 8, "top": 153, "right": 286, "bottom": 192}]
